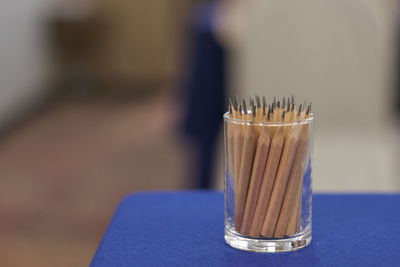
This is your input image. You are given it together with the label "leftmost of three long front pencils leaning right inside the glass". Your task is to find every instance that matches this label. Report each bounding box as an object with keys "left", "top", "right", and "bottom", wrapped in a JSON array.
[{"left": 241, "top": 126, "right": 271, "bottom": 235}]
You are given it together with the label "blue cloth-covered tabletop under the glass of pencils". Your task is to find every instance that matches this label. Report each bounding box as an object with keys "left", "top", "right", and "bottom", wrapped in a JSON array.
[{"left": 91, "top": 191, "right": 400, "bottom": 267}]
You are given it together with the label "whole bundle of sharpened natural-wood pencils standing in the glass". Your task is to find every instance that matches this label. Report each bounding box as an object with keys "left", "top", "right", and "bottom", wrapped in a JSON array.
[{"left": 226, "top": 95, "right": 311, "bottom": 238}]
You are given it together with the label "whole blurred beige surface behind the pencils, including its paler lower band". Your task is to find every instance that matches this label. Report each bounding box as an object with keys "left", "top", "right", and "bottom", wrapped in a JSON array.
[{"left": 220, "top": 0, "right": 400, "bottom": 191}]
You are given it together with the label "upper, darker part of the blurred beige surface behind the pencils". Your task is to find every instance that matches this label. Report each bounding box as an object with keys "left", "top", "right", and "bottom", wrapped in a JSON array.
[{"left": 228, "top": 0, "right": 396, "bottom": 129}]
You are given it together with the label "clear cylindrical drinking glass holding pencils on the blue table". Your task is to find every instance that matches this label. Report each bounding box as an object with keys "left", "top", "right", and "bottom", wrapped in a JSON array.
[{"left": 224, "top": 112, "right": 313, "bottom": 252}]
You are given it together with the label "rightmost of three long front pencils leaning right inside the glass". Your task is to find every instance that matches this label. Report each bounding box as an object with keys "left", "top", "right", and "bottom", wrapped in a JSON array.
[{"left": 261, "top": 126, "right": 301, "bottom": 238}]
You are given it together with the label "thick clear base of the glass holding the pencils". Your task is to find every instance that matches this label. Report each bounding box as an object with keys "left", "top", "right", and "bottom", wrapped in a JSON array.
[{"left": 225, "top": 227, "right": 311, "bottom": 253}]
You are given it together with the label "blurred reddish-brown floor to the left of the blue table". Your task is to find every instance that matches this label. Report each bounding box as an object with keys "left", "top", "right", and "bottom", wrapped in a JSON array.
[{"left": 0, "top": 93, "right": 187, "bottom": 267}]
